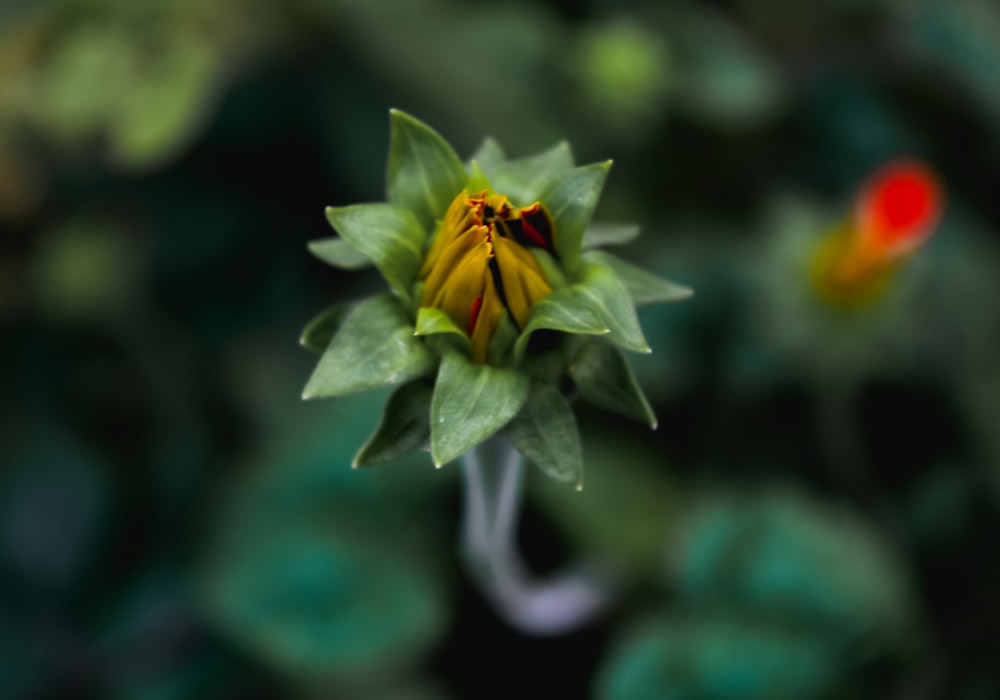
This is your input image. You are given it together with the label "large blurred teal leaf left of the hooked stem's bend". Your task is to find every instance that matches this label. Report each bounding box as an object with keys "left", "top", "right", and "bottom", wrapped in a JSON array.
[{"left": 205, "top": 519, "right": 445, "bottom": 683}]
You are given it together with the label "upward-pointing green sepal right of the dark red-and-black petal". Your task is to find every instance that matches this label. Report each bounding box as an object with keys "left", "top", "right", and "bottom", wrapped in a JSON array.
[{"left": 538, "top": 160, "right": 611, "bottom": 273}]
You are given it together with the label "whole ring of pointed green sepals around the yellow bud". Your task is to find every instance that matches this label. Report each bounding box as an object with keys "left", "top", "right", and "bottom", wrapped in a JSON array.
[{"left": 301, "top": 110, "right": 691, "bottom": 485}]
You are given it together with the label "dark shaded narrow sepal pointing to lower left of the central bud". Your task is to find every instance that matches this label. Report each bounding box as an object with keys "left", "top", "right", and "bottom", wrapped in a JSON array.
[{"left": 352, "top": 379, "right": 433, "bottom": 467}]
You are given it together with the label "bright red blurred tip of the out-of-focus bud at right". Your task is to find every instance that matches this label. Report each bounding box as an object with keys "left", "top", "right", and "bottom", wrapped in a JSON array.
[{"left": 860, "top": 162, "right": 943, "bottom": 249}]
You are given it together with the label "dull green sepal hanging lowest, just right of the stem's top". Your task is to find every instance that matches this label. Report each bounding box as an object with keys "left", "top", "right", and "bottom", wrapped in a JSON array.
[{"left": 507, "top": 382, "right": 583, "bottom": 489}]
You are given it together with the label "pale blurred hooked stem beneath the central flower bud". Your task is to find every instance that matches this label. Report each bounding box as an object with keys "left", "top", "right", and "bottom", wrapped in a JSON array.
[{"left": 462, "top": 437, "right": 616, "bottom": 635}]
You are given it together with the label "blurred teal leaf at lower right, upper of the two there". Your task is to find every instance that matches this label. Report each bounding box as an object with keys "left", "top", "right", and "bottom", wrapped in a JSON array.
[{"left": 673, "top": 494, "right": 914, "bottom": 650}]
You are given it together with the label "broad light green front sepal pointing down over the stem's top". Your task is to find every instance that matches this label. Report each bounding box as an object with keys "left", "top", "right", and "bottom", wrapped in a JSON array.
[{"left": 431, "top": 351, "right": 531, "bottom": 466}]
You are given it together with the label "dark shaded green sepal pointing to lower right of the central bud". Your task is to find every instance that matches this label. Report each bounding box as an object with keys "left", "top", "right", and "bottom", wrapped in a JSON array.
[{"left": 569, "top": 341, "right": 656, "bottom": 430}]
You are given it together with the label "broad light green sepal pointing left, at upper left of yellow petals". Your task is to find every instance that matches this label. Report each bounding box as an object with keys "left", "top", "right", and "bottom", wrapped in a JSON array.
[{"left": 326, "top": 203, "right": 424, "bottom": 301}]
